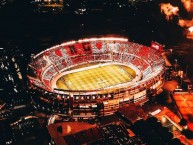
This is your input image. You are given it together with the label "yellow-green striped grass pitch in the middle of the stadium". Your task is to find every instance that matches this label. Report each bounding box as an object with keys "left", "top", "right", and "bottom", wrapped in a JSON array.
[{"left": 56, "top": 65, "right": 136, "bottom": 90}]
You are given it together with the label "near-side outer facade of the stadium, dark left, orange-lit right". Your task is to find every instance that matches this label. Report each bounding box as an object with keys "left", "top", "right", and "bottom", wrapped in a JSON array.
[{"left": 27, "top": 68, "right": 162, "bottom": 117}]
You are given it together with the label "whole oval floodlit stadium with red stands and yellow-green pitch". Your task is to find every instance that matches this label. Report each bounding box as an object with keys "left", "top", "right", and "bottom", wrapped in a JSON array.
[{"left": 28, "top": 37, "right": 165, "bottom": 118}]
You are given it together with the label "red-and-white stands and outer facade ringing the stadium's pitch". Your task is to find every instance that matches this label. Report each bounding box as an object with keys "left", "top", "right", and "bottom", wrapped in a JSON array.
[{"left": 25, "top": 40, "right": 164, "bottom": 119}]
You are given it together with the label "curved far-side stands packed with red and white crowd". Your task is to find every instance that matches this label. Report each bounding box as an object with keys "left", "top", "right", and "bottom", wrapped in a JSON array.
[{"left": 28, "top": 41, "right": 164, "bottom": 90}]
